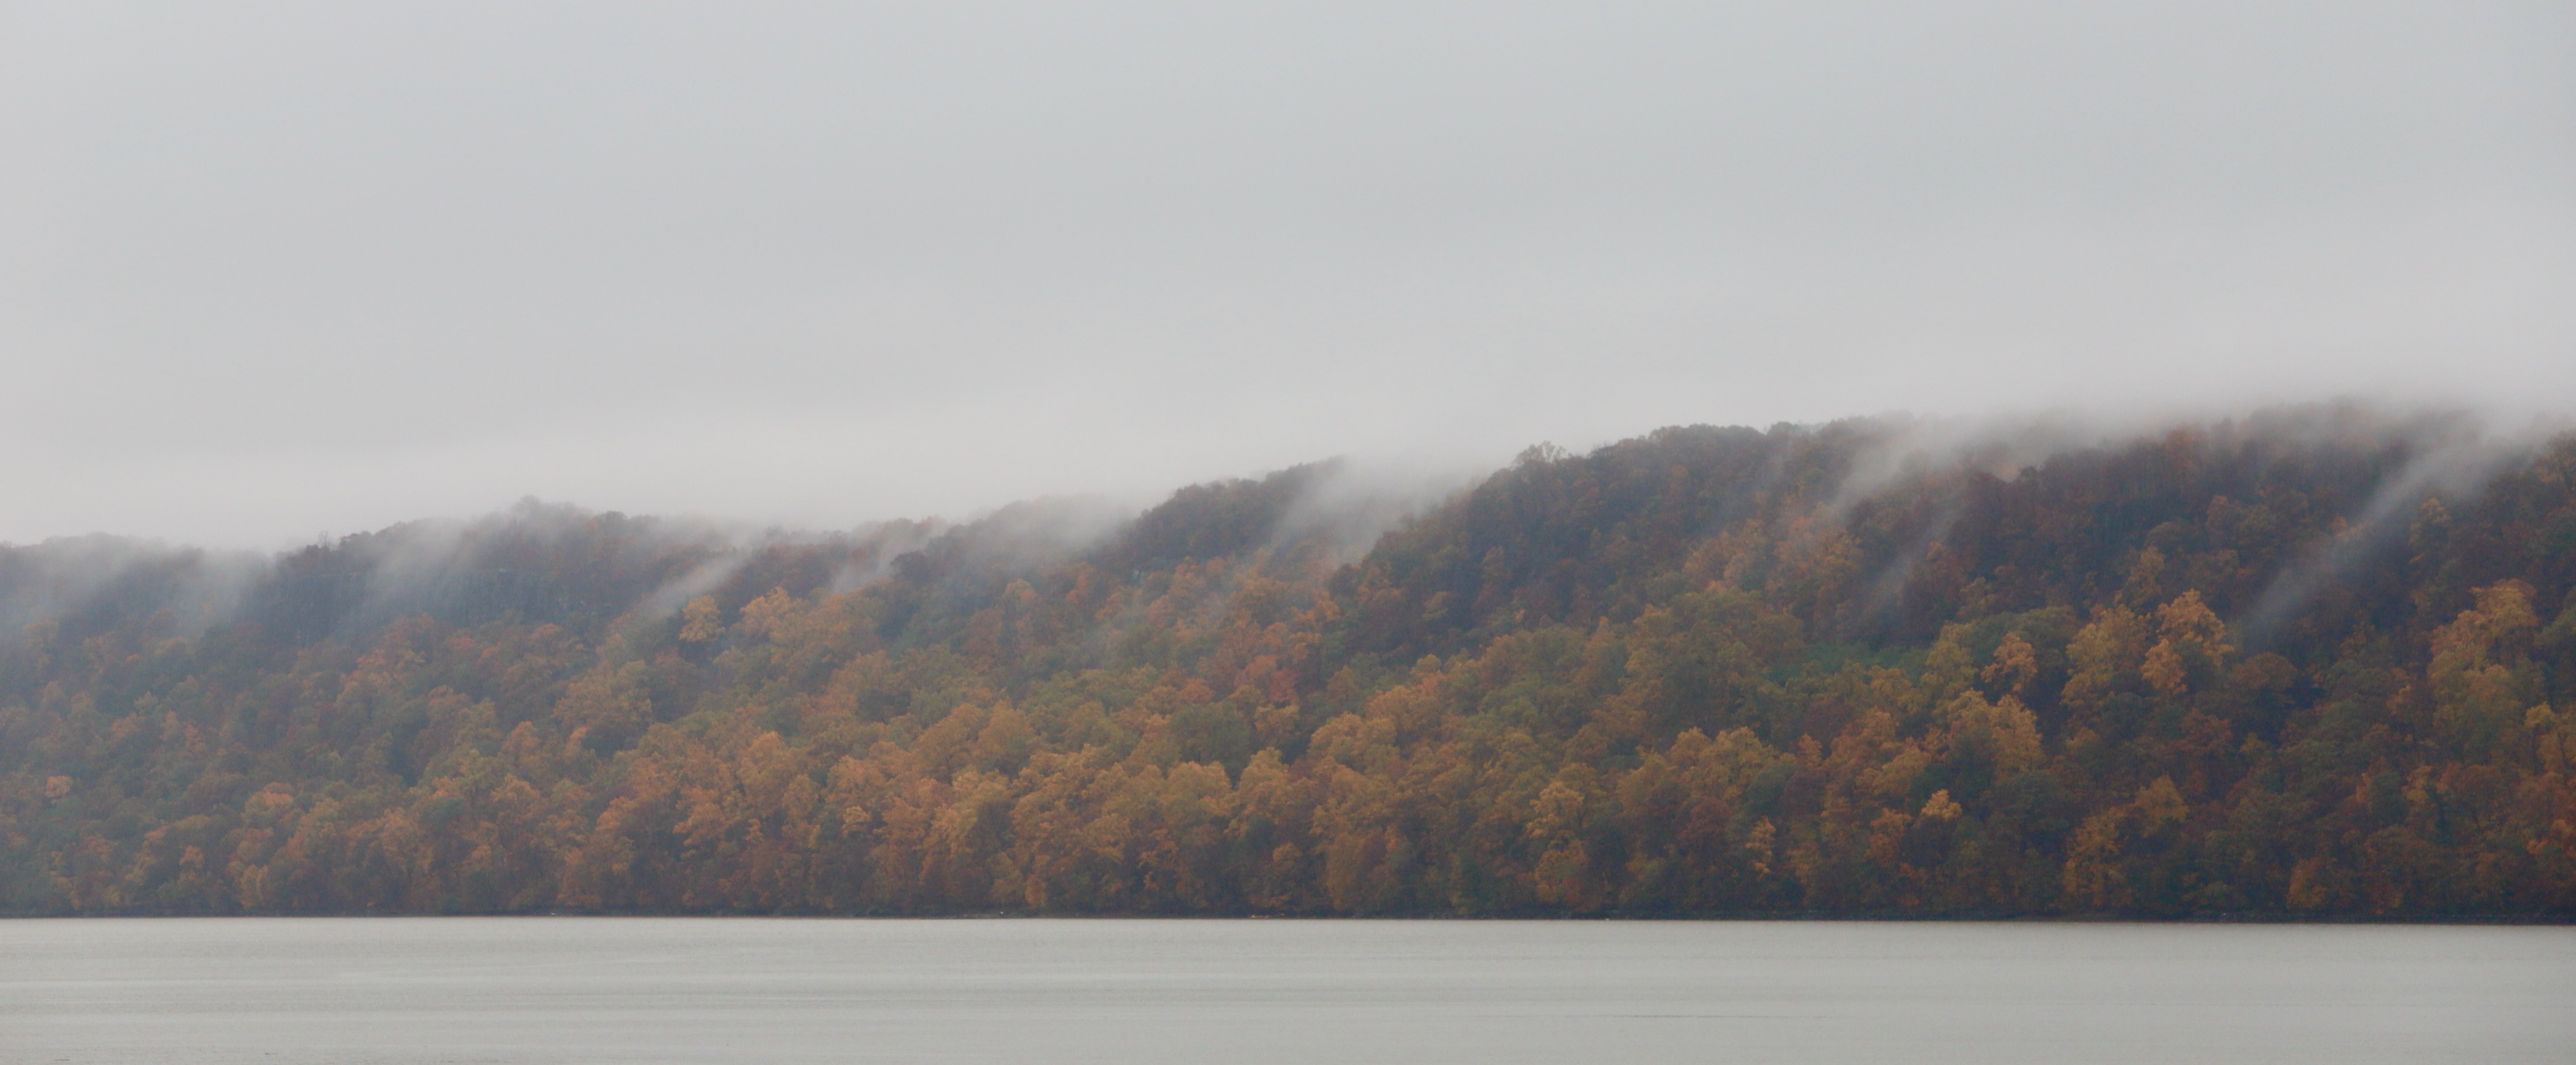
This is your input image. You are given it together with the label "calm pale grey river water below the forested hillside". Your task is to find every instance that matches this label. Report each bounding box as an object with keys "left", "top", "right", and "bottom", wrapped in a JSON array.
[{"left": 0, "top": 918, "right": 2576, "bottom": 1065}]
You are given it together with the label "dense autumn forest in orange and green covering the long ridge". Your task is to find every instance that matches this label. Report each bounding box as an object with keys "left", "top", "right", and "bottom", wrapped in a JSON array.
[{"left": 0, "top": 408, "right": 2576, "bottom": 918}]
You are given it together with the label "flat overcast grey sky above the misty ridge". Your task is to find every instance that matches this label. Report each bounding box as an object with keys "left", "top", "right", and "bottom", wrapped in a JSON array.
[{"left": 0, "top": 0, "right": 2576, "bottom": 547}]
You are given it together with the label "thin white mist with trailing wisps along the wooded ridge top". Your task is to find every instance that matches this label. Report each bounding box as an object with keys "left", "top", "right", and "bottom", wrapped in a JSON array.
[{"left": 0, "top": 405, "right": 2566, "bottom": 655}]
